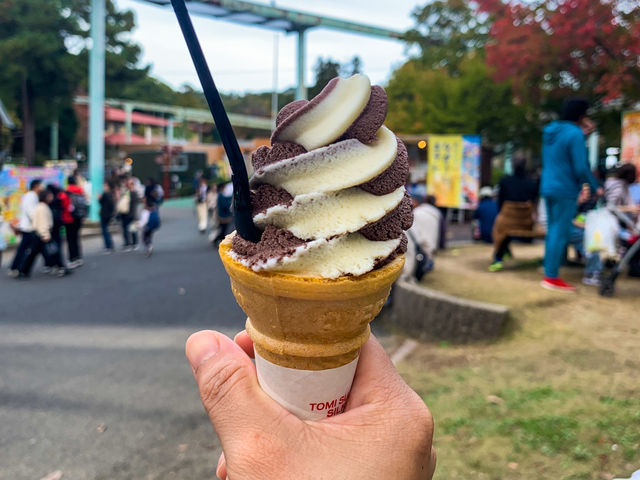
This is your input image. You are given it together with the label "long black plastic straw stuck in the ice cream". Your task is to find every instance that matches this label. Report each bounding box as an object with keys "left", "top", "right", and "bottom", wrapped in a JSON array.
[{"left": 171, "top": 0, "right": 260, "bottom": 242}]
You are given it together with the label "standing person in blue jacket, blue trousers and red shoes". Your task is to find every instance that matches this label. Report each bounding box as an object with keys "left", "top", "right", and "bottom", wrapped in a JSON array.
[{"left": 540, "top": 98, "right": 602, "bottom": 292}]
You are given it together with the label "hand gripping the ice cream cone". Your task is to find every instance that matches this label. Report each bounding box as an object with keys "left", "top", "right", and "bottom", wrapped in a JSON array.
[{"left": 186, "top": 330, "right": 436, "bottom": 480}]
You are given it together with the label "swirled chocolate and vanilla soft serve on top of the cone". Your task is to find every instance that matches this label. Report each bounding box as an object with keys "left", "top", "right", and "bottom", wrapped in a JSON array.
[{"left": 231, "top": 75, "right": 413, "bottom": 278}]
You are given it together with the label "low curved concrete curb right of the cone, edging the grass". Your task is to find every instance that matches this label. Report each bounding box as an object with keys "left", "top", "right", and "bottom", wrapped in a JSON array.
[{"left": 390, "top": 281, "right": 509, "bottom": 343}]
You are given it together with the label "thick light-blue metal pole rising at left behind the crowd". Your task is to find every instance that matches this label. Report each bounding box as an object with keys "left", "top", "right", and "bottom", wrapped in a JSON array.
[{"left": 89, "top": 0, "right": 105, "bottom": 221}]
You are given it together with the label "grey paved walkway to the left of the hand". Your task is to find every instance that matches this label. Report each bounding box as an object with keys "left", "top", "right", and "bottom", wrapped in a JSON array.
[{"left": 0, "top": 204, "right": 244, "bottom": 480}]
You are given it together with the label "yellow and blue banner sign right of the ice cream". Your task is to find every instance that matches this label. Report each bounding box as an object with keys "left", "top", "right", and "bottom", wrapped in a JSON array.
[{"left": 427, "top": 135, "right": 481, "bottom": 209}]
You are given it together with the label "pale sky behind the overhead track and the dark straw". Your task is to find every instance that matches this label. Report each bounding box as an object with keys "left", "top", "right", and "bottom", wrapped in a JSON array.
[{"left": 116, "top": 0, "right": 424, "bottom": 92}]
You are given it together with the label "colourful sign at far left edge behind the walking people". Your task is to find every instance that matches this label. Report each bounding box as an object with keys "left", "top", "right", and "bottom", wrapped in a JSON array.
[{"left": 0, "top": 166, "right": 65, "bottom": 244}]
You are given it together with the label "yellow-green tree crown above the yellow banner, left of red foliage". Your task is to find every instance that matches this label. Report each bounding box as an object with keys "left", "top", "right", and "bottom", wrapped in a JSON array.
[{"left": 386, "top": 53, "right": 532, "bottom": 144}]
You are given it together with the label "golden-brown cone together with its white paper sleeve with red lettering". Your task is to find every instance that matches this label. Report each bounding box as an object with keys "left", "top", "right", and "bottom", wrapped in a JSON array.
[{"left": 219, "top": 234, "right": 404, "bottom": 419}]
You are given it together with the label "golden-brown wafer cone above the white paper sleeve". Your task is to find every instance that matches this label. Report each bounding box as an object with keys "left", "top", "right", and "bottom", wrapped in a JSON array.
[{"left": 219, "top": 236, "right": 404, "bottom": 370}]
